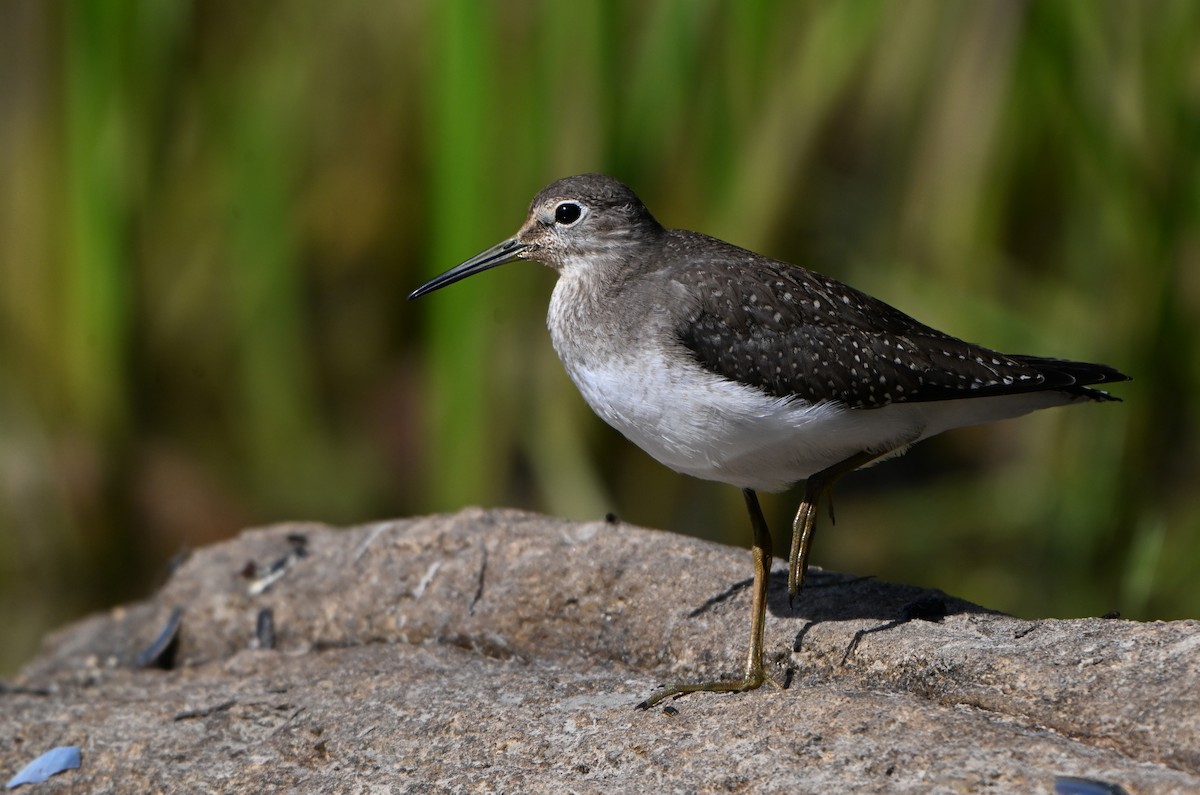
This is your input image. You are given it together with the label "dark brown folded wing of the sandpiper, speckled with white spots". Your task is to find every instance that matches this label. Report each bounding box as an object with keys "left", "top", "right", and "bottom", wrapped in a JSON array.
[{"left": 677, "top": 235, "right": 1127, "bottom": 408}]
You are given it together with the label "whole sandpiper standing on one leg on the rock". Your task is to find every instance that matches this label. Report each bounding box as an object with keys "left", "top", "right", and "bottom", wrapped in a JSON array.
[{"left": 408, "top": 174, "right": 1128, "bottom": 707}]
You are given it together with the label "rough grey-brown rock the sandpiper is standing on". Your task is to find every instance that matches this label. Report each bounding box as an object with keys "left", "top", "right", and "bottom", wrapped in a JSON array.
[{"left": 0, "top": 509, "right": 1200, "bottom": 793}]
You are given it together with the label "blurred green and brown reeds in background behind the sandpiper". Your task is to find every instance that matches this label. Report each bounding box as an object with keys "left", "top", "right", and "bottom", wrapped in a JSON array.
[{"left": 0, "top": 0, "right": 1200, "bottom": 671}]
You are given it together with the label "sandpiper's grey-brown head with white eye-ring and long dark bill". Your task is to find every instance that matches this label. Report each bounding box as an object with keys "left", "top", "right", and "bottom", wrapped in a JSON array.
[{"left": 408, "top": 174, "right": 662, "bottom": 300}]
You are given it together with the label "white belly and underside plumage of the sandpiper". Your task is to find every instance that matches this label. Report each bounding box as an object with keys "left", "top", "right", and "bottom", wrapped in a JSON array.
[{"left": 564, "top": 346, "right": 1073, "bottom": 491}]
